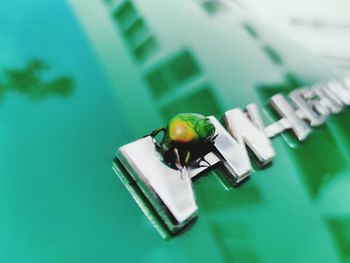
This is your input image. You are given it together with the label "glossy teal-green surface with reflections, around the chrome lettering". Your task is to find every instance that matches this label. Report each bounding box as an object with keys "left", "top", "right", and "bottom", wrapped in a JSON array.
[{"left": 0, "top": 0, "right": 350, "bottom": 263}]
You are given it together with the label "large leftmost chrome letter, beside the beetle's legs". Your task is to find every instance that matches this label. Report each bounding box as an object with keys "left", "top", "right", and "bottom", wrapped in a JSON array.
[{"left": 118, "top": 136, "right": 198, "bottom": 233}]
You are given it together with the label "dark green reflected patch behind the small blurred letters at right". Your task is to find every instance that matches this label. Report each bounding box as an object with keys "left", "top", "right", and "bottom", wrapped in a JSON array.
[{"left": 257, "top": 77, "right": 346, "bottom": 198}]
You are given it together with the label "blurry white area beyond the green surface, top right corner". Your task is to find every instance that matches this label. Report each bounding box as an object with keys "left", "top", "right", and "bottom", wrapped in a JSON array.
[{"left": 238, "top": 0, "right": 350, "bottom": 74}]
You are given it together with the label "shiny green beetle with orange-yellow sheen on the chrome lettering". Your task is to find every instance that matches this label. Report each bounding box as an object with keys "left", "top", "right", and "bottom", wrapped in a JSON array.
[{"left": 150, "top": 113, "right": 216, "bottom": 175}]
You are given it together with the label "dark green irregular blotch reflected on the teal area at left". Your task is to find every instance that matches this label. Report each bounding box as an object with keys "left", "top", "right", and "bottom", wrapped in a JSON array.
[{"left": 0, "top": 59, "right": 74, "bottom": 100}]
